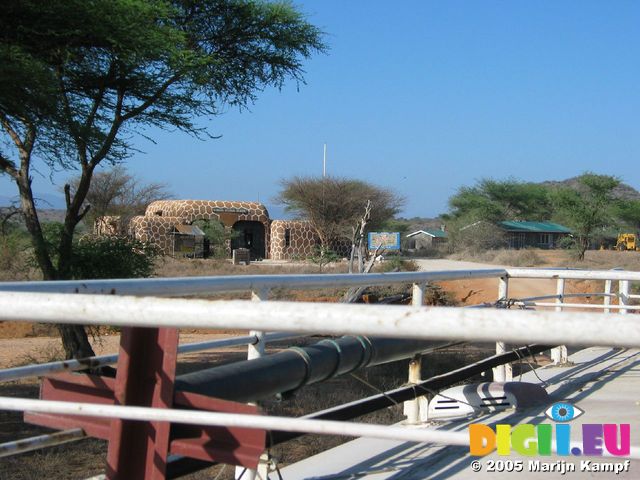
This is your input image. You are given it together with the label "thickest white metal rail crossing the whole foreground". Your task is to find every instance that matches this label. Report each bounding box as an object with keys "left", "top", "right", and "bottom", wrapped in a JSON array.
[{"left": 0, "top": 292, "right": 640, "bottom": 347}]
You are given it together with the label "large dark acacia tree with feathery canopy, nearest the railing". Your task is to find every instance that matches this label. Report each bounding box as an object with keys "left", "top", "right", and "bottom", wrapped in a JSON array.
[{"left": 0, "top": 0, "right": 325, "bottom": 357}]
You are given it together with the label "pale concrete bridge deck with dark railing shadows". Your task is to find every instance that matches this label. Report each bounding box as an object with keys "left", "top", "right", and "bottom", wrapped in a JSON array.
[{"left": 282, "top": 347, "right": 640, "bottom": 480}]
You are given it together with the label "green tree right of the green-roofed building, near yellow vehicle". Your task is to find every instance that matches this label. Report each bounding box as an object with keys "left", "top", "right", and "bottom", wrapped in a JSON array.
[{"left": 553, "top": 172, "right": 620, "bottom": 260}]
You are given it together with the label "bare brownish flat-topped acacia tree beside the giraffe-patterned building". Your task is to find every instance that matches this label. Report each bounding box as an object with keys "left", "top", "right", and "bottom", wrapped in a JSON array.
[{"left": 276, "top": 176, "right": 404, "bottom": 249}]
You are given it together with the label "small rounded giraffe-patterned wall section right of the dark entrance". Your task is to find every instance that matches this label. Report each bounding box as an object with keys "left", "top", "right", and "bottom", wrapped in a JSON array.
[{"left": 270, "top": 220, "right": 320, "bottom": 260}]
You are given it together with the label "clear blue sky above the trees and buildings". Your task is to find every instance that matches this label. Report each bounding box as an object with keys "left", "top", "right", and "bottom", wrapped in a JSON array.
[{"left": 0, "top": 0, "right": 640, "bottom": 216}]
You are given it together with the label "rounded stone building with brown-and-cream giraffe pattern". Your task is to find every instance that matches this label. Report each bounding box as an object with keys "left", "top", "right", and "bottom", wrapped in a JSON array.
[{"left": 100, "top": 200, "right": 319, "bottom": 260}]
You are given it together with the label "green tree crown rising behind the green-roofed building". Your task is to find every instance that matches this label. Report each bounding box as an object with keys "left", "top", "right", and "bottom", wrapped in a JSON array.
[{"left": 449, "top": 179, "right": 552, "bottom": 223}]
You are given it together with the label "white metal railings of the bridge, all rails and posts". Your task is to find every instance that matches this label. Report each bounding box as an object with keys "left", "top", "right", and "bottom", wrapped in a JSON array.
[{"left": 0, "top": 268, "right": 640, "bottom": 478}]
